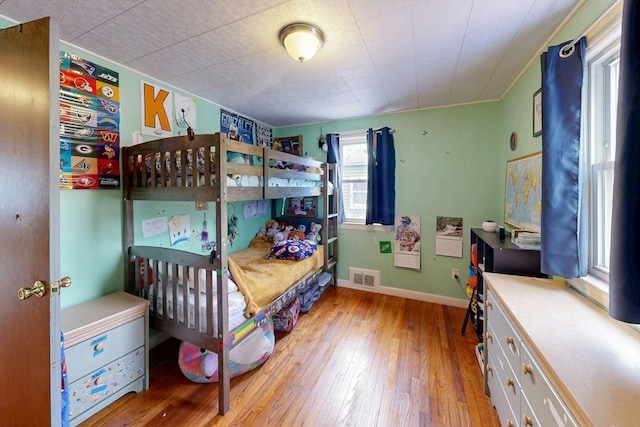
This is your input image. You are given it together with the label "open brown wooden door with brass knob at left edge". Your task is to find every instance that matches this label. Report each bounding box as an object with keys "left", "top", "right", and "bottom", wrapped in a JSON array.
[{"left": 0, "top": 18, "right": 61, "bottom": 426}]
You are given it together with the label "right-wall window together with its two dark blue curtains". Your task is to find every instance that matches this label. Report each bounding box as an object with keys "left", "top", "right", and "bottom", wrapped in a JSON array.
[{"left": 541, "top": 0, "right": 640, "bottom": 323}]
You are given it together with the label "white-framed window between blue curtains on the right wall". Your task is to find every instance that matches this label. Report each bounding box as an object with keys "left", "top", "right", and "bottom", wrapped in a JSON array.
[{"left": 569, "top": 2, "right": 622, "bottom": 307}]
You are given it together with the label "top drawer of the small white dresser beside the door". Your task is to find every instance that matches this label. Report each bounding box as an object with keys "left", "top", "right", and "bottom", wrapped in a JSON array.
[{"left": 65, "top": 317, "right": 146, "bottom": 383}]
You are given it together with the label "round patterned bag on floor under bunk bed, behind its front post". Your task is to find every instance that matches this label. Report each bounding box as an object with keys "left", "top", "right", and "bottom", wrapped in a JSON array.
[{"left": 178, "top": 319, "right": 275, "bottom": 383}]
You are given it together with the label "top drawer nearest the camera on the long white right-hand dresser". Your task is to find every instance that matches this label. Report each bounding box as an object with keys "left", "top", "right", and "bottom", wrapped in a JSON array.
[{"left": 520, "top": 346, "right": 580, "bottom": 426}]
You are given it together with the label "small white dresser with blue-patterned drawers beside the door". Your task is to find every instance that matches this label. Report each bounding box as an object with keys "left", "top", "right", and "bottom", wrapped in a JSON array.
[{"left": 61, "top": 292, "right": 149, "bottom": 425}]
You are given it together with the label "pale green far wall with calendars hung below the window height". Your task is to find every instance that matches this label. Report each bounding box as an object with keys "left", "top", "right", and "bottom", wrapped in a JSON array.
[{"left": 277, "top": 102, "right": 504, "bottom": 298}]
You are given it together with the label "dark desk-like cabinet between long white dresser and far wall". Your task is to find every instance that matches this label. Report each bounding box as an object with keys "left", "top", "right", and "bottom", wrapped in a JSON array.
[{"left": 462, "top": 228, "right": 547, "bottom": 342}]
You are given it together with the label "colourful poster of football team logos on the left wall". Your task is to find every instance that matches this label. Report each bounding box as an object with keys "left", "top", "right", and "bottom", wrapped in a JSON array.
[{"left": 59, "top": 51, "right": 120, "bottom": 190}]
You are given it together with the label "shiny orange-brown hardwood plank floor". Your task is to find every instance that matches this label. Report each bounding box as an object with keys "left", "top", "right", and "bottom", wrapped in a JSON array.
[{"left": 82, "top": 287, "right": 500, "bottom": 427}]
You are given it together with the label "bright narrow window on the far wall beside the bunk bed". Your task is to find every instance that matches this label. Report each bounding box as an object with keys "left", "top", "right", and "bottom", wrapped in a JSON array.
[{"left": 340, "top": 130, "right": 367, "bottom": 224}]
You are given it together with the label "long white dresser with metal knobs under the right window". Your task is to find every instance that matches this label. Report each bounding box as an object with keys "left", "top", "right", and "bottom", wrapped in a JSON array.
[{"left": 484, "top": 273, "right": 640, "bottom": 427}]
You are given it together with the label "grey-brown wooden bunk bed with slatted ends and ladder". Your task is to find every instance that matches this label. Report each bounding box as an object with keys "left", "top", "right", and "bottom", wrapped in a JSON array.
[{"left": 122, "top": 133, "right": 338, "bottom": 415}]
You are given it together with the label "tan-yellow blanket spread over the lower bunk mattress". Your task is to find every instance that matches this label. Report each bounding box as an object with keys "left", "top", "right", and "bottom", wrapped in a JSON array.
[{"left": 229, "top": 241, "right": 324, "bottom": 317}]
